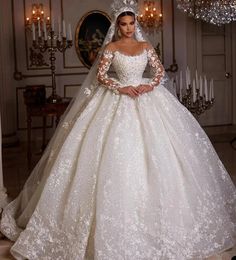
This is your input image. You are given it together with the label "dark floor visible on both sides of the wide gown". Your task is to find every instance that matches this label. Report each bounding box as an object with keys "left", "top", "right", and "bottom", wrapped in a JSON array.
[{"left": 0, "top": 134, "right": 236, "bottom": 260}]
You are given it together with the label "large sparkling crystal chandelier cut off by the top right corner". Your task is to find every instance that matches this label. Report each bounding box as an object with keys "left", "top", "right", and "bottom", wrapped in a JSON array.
[{"left": 177, "top": 0, "right": 236, "bottom": 26}]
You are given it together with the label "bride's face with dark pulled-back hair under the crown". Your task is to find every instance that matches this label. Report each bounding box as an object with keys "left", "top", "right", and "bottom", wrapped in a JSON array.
[{"left": 118, "top": 15, "right": 135, "bottom": 38}]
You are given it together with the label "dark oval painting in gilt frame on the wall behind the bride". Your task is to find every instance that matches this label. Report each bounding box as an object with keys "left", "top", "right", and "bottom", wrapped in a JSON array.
[{"left": 75, "top": 10, "right": 111, "bottom": 68}]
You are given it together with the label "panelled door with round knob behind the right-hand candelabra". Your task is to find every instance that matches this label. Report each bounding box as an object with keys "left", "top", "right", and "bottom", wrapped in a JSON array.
[{"left": 197, "top": 22, "right": 233, "bottom": 126}]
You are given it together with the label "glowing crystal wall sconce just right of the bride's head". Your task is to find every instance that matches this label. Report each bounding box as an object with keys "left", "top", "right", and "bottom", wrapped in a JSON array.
[{"left": 138, "top": 0, "right": 163, "bottom": 34}]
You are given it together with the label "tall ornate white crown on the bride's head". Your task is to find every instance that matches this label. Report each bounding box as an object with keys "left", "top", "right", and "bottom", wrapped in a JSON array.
[{"left": 111, "top": 0, "right": 138, "bottom": 19}]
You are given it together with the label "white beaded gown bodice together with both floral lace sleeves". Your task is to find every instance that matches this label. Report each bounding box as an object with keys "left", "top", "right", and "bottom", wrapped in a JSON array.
[{"left": 97, "top": 48, "right": 164, "bottom": 93}]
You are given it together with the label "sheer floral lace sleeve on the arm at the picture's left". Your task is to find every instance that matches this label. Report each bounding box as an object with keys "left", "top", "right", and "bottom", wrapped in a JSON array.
[{"left": 97, "top": 50, "right": 119, "bottom": 94}]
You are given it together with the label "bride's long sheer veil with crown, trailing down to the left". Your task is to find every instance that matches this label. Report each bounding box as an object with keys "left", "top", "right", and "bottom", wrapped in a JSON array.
[{"left": 1, "top": 0, "right": 175, "bottom": 223}]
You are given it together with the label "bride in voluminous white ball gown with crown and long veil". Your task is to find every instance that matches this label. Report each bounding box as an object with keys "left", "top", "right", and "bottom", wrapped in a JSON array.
[{"left": 1, "top": 0, "right": 236, "bottom": 260}]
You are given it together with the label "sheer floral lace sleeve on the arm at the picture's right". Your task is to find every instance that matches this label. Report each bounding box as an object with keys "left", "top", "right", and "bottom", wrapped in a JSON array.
[{"left": 147, "top": 47, "right": 165, "bottom": 87}]
